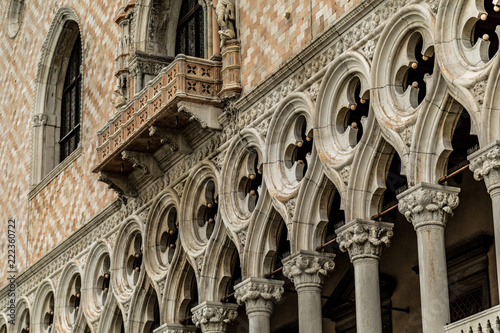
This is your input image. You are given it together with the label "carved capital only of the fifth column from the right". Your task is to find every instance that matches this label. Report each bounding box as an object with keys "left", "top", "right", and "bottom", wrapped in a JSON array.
[{"left": 234, "top": 278, "right": 285, "bottom": 315}]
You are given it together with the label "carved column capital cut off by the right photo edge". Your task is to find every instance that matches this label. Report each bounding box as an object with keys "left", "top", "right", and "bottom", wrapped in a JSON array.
[{"left": 469, "top": 141, "right": 500, "bottom": 194}]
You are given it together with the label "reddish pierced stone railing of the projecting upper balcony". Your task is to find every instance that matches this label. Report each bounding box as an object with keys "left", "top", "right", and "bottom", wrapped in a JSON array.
[{"left": 94, "top": 55, "right": 222, "bottom": 173}]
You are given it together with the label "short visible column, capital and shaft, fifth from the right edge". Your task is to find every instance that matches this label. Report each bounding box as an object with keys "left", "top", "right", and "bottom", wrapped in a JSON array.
[{"left": 234, "top": 278, "right": 285, "bottom": 333}]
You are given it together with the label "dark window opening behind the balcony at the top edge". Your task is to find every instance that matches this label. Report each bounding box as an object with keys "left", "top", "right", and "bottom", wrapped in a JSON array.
[{"left": 175, "top": 0, "right": 205, "bottom": 58}]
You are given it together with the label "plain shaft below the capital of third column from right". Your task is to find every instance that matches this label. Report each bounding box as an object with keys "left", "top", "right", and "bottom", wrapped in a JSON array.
[{"left": 353, "top": 258, "right": 382, "bottom": 333}]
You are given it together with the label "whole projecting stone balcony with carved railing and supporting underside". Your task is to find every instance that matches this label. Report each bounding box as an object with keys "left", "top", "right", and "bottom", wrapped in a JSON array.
[{"left": 93, "top": 55, "right": 222, "bottom": 178}]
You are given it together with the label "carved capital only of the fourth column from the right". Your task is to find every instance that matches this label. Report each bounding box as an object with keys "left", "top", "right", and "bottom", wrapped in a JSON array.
[{"left": 283, "top": 250, "right": 335, "bottom": 289}]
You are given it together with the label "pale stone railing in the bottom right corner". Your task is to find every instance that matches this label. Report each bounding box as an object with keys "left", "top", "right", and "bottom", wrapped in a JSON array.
[{"left": 444, "top": 305, "right": 500, "bottom": 333}]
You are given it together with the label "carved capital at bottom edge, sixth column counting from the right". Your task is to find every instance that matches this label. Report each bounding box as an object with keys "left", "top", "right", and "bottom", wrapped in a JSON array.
[{"left": 191, "top": 301, "right": 238, "bottom": 333}]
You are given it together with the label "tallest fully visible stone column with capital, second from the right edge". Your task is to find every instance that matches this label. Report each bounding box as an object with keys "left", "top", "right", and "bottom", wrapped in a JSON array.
[{"left": 398, "top": 183, "right": 460, "bottom": 333}]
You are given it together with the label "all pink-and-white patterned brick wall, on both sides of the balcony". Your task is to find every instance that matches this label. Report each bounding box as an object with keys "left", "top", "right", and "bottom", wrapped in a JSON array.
[{"left": 0, "top": 0, "right": 352, "bottom": 285}]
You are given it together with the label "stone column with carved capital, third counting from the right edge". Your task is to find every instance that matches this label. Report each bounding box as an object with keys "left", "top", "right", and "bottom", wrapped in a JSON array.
[{"left": 335, "top": 219, "right": 393, "bottom": 333}]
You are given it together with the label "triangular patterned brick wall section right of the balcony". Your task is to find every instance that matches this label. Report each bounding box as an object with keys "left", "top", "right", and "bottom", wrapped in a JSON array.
[{"left": 239, "top": 0, "right": 360, "bottom": 93}]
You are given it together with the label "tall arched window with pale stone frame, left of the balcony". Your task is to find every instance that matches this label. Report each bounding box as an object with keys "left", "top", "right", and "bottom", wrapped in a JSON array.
[{"left": 30, "top": 7, "right": 82, "bottom": 188}]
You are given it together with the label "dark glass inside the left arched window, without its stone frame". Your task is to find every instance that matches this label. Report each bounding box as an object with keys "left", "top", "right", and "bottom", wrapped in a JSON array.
[{"left": 59, "top": 36, "right": 82, "bottom": 161}]
